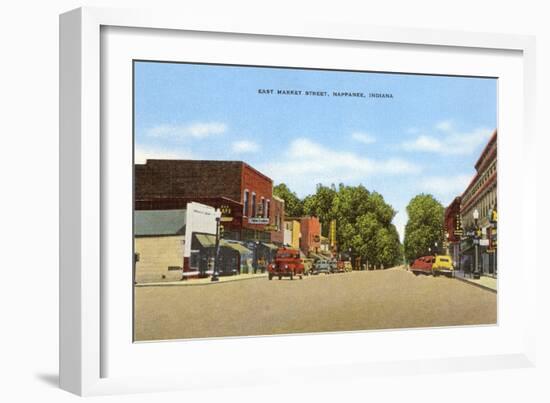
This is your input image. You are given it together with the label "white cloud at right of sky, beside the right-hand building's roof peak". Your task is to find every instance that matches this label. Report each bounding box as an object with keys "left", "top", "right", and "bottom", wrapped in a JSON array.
[{"left": 402, "top": 127, "right": 493, "bottom": 155}]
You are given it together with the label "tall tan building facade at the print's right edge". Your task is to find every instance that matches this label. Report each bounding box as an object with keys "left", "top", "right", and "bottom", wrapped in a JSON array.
[{"left": 460, "top": 130, "right": 497, "bottom": 276}]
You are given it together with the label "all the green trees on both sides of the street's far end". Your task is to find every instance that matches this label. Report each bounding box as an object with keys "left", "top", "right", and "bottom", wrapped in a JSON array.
[{"left": 273, "top": 183, "right": 445, "bottom": 267}]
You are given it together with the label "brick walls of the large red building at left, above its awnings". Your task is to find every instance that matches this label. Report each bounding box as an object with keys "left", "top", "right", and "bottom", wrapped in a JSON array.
[{"left": 134, "top": 160, "right": 284, "bottom": 242}]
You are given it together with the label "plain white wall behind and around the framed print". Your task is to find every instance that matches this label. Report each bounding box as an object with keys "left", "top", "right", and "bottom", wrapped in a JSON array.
[{"left": 0, "top": 0, "right": 550, "bottom": 403}]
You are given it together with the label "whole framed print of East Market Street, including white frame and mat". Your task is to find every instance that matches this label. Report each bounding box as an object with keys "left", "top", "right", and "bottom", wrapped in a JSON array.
[{"left": 60, "top": 9, "right": 536, "bottom": 394}]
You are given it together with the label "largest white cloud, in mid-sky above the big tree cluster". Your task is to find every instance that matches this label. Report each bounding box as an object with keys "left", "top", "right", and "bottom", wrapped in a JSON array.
[{"left": 259, "top": 138, "right": 420, "bottom": 196}]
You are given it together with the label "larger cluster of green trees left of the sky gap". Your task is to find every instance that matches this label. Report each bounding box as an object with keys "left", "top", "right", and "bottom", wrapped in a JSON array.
[{"left": 273, "top": 183, "right": 403, "bottom": 267}]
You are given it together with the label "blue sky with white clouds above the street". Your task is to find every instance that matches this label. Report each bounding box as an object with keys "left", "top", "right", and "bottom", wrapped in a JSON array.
[{"left": 135, "top": 62, "right": 497, "bottom": 241}]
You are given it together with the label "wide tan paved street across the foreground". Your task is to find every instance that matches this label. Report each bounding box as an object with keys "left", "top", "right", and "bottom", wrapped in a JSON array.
[{"left": 135, "top": 268, "right": 497, "bottom": 341}]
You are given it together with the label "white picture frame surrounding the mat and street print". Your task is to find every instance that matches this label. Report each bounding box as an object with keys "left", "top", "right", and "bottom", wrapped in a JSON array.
[{"left": 60, "top": 8, "right": 537, "bottom": 395}]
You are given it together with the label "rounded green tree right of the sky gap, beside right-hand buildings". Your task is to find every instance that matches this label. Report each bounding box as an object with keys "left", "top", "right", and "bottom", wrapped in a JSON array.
[{"left": 404, "top": 193, "right": 445, "bottom": 262}]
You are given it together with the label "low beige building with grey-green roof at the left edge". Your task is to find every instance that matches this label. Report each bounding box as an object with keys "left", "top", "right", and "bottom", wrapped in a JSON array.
[{"left": 134, "top": 210, "right": 186, "bottom": 283}]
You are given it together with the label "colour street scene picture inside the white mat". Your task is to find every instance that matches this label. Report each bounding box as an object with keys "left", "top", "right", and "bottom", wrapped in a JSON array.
[{"left": 133, "top": 61, "right": 498, "bottom": 341}]
